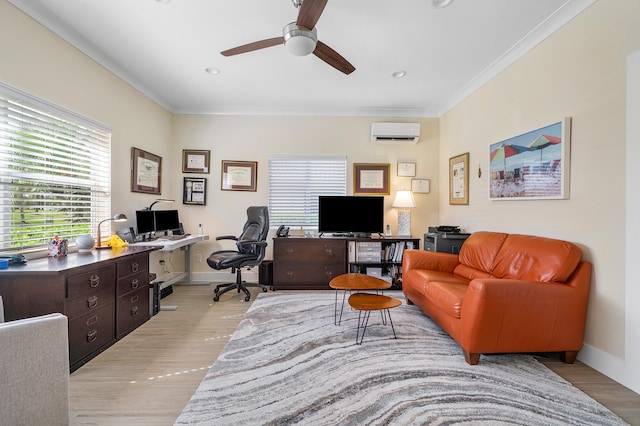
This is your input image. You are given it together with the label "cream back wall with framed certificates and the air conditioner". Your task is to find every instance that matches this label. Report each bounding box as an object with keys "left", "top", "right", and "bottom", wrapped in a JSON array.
[{"left": 172, "top": 115, "right": 440, "bottom": 281}]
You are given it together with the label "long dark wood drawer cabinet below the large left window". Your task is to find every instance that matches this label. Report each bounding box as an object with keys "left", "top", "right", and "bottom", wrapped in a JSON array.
[{"left": 0, "top": 247, "right": 154, "bottom": 371}]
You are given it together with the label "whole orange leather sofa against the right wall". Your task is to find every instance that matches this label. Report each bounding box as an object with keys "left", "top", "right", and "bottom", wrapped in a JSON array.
[{"left": 402, "top": 232, "right": 591, "bottom": 365}]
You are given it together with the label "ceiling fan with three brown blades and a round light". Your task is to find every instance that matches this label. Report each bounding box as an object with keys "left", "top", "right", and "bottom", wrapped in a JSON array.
[{"left": 220, "top": 0, "right": 355, "bottom": 74}]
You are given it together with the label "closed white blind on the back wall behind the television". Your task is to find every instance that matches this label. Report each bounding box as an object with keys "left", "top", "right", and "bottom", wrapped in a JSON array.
[{"left": 269, "top": 156, "right": 347, "bottom": 227}]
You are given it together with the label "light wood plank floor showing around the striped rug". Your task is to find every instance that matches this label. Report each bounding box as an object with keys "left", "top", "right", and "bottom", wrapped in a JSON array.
[{"left": 70, "top": 286, "right": 640, "bottom": 426}]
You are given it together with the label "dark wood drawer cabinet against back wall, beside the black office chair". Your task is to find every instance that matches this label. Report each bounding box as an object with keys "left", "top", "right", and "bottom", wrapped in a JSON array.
[{"left": 273, "top": 237, "right": 347, "bottom": 290}]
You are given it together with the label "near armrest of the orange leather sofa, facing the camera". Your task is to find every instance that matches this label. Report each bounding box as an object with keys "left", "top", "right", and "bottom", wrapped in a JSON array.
[{"left": 460, "top": 265, "right": 590, "bottom": 352}]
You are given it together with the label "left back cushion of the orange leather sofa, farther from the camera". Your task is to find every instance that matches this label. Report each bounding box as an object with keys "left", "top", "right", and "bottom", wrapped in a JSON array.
[{"left": 456, "top": 231, "right": 508, "bottom": 279}]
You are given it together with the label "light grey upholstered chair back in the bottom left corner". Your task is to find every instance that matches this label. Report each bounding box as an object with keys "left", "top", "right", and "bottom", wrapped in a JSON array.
[{"left": 0, "top": 297, "right": 69, "bottom": 426}]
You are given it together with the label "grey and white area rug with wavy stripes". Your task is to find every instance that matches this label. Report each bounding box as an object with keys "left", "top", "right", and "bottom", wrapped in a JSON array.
[{"left": 176, "top": 291, "right": 625, "bottom": 426}]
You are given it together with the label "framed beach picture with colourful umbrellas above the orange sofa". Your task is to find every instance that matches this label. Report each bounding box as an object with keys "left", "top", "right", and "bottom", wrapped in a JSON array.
[{"left": 489, "top": 117, "right": 571, "bottom": 200}]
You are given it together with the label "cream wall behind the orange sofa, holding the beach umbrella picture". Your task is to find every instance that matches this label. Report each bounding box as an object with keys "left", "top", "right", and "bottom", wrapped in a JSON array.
[{"left": 440, "top": 0, "right": 640, "bottom": 391}]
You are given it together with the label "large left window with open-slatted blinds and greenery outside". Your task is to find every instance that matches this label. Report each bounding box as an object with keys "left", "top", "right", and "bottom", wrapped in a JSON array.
[{"left": 0, "top": 83, "right": 111, "bottom": 251}]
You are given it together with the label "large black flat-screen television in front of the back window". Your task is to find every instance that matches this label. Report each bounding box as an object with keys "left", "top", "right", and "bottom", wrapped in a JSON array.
[{"left": 318, "top": 196, "right": 384, "bottom": 234}]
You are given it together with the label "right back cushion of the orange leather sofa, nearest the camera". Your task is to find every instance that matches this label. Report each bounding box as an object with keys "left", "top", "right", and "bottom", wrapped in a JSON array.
[{"left": 490, "top": 234, "right": 582, "bottom": 282}]
